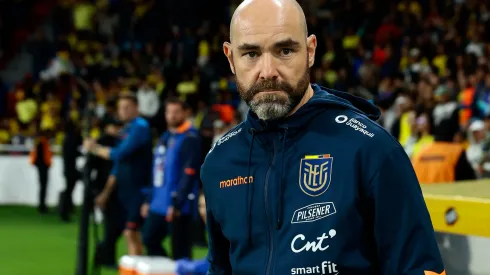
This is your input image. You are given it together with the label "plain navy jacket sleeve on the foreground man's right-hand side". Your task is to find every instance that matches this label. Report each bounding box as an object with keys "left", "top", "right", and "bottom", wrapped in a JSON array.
[{"left": 368, "top": 146, "right": 445, "bottom": 275}]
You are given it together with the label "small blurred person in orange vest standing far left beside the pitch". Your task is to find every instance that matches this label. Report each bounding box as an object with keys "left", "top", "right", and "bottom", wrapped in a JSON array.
[{"left": 30, "top": 131, "right": 53, "bottom": 214}]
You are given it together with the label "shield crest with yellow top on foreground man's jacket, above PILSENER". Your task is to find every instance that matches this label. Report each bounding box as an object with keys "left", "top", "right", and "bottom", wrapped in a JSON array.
[{"left": 299, "top": 155, "right": 333, "bottom": 197}]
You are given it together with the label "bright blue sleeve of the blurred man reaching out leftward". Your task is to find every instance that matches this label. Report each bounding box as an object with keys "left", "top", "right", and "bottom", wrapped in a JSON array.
[{"left": 110, "top": 123, "right": 151, "bottom": 161}]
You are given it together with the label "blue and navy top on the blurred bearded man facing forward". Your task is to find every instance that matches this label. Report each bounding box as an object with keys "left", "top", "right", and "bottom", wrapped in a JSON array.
[{"left": 150, "top": 122, "right": 201, "bottom": 215}]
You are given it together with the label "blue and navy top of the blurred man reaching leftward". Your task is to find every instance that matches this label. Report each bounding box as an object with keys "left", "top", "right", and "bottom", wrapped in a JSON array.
[{"left": 110, "top": 117, "right": 153, "bottom": 202}]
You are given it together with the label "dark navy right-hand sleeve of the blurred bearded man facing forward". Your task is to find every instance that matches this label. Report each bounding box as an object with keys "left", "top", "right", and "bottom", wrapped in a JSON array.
[{"left": 173, "top": 136, "right": 201, "bottom": 209}]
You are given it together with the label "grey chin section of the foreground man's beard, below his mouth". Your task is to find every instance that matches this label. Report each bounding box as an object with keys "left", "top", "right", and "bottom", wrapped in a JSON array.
[{"left": 249, "top": 95, "right": 292, "bottom": 120}]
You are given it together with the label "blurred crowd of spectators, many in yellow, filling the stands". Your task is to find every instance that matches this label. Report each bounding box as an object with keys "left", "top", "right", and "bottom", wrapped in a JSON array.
[{"left": 0, "top": 0, "right": 490, "bottom": 179}]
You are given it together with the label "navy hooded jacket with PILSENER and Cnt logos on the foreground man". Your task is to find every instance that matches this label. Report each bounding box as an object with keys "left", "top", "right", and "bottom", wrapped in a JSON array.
[{"left": 201, "top": 85, "right": 444, "bottom": 275}]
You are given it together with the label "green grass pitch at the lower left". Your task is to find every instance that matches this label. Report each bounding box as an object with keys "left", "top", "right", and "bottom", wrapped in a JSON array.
[{"left": 0, "top": 206, "right": 206, "bottom": 275}]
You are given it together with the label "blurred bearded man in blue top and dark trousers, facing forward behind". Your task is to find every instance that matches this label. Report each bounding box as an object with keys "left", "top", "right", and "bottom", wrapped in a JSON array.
[{"left": 141, "top": 98, "right": 201, "bottom": 259}]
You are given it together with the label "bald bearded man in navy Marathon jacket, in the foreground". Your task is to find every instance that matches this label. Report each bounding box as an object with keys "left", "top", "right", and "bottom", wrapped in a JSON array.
[{"left": 201, "top": 0, "right": 445, "bottom": 275}]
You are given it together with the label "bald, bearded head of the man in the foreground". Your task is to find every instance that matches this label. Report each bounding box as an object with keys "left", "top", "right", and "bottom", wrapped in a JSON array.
[{"left": 223, "top": 0, "right": 316, "bottom": 120}]
